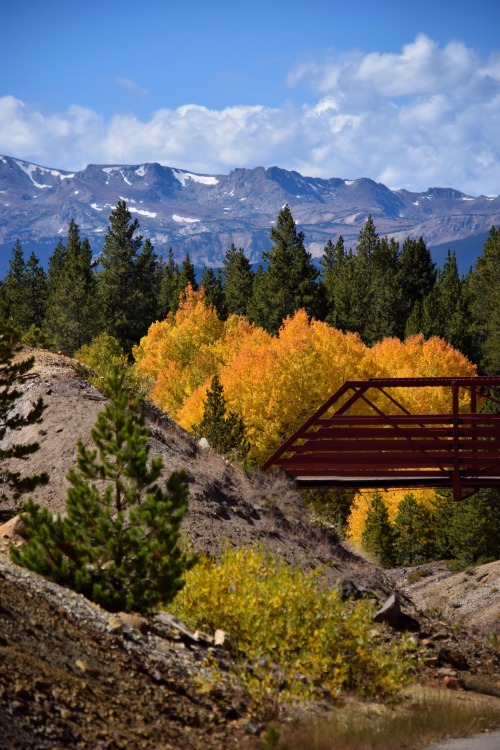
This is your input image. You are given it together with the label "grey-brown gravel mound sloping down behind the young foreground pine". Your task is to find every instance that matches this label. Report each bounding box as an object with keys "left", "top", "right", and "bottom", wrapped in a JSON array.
[{"left": 0, "top": 350, "right": 388, "bottom": 598}]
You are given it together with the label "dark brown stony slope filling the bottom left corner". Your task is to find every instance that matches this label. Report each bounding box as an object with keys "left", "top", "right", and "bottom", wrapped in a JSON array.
[{"left": 0, "top": 560, "right": 249, "bottom": 750}]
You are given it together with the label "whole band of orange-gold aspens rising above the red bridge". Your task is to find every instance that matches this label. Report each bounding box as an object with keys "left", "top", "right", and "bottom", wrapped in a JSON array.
[{"left": 134, "top": 288, "right": 475, "bottom": 462}]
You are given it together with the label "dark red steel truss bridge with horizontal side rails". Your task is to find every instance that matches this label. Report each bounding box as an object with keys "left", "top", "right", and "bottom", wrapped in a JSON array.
[{"left": 262, "top": 376, "right": 500, "bottom": 500}]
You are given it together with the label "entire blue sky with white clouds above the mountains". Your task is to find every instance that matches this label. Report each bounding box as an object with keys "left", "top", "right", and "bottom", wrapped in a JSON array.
[{"left": 0, "top": 0, "right": 500, "bottom": 195}]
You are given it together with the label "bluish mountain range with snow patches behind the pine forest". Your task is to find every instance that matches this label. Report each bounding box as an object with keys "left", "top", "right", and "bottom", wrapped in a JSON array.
[{"left": 0, "top": 156, "right": 500, "bottom": 274}]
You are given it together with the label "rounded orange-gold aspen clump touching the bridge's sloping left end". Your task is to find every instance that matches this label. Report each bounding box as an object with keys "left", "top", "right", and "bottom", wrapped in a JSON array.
[{"left": 220, "top": 310, "right": 366, "bottom": 461}]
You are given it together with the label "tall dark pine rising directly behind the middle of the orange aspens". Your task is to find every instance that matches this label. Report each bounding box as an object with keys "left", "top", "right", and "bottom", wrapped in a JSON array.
[{"left": 249, "top": 205, "right": 318, "bottom": 333}]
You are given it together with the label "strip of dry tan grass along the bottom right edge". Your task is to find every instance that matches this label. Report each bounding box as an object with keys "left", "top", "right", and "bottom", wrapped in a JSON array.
[{"left": 260, "top": 687, "right": 500, "bottom": 750}]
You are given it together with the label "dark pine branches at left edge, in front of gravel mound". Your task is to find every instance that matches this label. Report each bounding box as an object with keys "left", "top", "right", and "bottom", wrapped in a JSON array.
[{"left": 0, "top": 319, "right": 48, "bottom": 508}]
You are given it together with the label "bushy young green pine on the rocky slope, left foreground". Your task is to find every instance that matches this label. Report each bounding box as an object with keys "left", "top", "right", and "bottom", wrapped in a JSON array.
[{"left": 11, "top": 369, "right": 193, "bottom": 612}]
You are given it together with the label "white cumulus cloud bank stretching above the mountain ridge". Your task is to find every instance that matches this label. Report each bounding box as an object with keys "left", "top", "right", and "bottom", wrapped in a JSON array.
[{"left": 0, "top": 35, "right": 500, "bottom": 194}]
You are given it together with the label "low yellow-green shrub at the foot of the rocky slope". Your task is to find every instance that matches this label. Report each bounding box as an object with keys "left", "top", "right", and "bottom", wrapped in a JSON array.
[{"left": 170, "top": 547, "right": 412, "bottom": 706}]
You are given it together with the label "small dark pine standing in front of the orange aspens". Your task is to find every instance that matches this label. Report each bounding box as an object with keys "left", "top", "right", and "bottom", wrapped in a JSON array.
[{"left": 195, "top": 375, "right": 249, "bottom": 457}]
